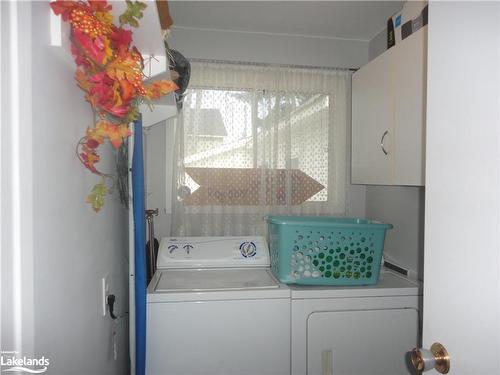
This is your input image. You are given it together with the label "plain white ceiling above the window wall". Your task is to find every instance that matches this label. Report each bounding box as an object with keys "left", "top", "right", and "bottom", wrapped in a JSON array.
[{"left": 169, "top": 0, "right": 403, "bottom": 41}]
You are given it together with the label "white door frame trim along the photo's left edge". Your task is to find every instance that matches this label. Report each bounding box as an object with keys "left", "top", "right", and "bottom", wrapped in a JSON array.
[{"left": 0, "top": 1, "right": 34, "bottom": 355}]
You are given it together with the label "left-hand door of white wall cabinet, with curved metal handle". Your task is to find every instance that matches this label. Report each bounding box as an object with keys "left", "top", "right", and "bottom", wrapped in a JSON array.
[{"left": 351, "top": 48, "right": 394, "bottom": 184}]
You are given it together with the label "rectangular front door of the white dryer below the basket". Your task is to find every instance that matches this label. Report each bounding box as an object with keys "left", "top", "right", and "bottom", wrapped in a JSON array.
[{"left": 307, "top": 309, "right": 418, "bottom": 375}]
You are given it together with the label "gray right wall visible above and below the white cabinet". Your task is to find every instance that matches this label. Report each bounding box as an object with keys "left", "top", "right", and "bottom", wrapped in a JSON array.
[{"left": 366, "top": 25, "right": 425, "bottom": 279}]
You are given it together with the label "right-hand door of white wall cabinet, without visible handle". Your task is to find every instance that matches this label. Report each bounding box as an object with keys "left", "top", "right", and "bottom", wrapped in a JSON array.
[{"left": 393, "top": 27, "right": 427, "bottom": 185}]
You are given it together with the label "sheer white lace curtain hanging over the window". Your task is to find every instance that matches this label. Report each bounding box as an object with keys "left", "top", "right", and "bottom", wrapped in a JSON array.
[{"left": 171, "top": 62, "right": 350, "bottom": 236}]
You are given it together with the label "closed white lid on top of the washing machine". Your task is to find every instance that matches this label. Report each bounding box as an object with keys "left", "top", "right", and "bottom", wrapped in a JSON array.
[{"left": 154, "top": 268, "right": 279, "bottom": 293}]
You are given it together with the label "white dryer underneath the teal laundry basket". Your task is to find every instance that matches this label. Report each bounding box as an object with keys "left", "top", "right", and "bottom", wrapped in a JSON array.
[{"left": 290, "top": 269, "right": 421, "bottom": 375}]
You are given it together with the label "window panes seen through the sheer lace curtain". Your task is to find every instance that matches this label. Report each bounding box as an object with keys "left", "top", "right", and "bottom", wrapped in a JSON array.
[{"left": 184, "top": 88, "right": 329, "bottom": 204}]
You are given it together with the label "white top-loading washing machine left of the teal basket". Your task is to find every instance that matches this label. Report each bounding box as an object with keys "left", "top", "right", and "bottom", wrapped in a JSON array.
[{"left": 146, "top": 237, "right": 290, "bottom": 375}]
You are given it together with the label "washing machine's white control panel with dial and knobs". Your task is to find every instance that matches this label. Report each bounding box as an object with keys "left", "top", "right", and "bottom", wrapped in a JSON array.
[{"left": 156, "top": 237, "right": 270, "bottom": 269}]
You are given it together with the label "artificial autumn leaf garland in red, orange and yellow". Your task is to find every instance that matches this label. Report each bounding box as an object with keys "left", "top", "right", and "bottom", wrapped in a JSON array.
[{"left": 50, "top": 0, "right": 178, "bottom": 212}]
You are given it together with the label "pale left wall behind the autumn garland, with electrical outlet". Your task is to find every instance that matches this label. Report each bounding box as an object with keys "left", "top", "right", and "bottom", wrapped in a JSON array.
[{"left": 1, "top": 2, "right": 128, "bottom": 375}]
